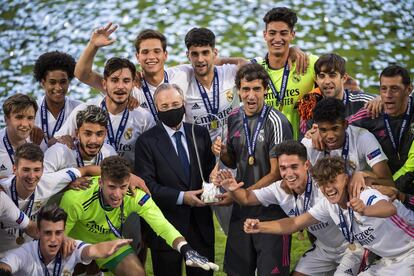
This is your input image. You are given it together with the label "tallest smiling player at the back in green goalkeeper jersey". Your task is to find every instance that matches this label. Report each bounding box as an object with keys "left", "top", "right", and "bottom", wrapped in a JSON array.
[{"left": 254, "top": 7, "right": 317, "bottom": 139}]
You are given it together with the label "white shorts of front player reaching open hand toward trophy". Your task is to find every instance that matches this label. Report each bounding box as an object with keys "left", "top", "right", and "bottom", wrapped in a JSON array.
[{"left": 295, "top": 241, "right": 364, "bottom": 276}]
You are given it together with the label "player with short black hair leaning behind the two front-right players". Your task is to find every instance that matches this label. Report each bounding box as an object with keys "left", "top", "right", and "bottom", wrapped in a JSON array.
[{"left": 302, "top": 98, "right": 392, "bottom": 184}]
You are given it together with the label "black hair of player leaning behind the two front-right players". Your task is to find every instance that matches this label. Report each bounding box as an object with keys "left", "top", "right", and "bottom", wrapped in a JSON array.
[{"left": 313, "top": 97, "right": 345, "bottom": 123}]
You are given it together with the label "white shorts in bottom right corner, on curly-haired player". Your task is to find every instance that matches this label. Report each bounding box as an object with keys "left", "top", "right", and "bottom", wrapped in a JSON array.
[{"left": 358, "top": 249, "right": 414, "bottom": 276}]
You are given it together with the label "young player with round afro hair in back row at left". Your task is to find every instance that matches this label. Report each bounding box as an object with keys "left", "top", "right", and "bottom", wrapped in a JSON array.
[{"left": 33, "top": 51, "right": 81, "bottom": 145}]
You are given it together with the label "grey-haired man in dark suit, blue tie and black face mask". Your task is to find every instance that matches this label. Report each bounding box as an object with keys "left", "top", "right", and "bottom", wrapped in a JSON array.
[{"left": 135, "top": 84, "right": 215, "bottom": 276}]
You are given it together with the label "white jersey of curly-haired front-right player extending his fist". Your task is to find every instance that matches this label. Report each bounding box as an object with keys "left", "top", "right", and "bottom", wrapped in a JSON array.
[{"left": 309, "top": 188, "right": 414, "bottom": 258}]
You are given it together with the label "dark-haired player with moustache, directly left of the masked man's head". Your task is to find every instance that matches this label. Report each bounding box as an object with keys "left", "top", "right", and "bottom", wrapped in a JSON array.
[{"left": 55, "top": 57, "right": 155, "bottom": 165}]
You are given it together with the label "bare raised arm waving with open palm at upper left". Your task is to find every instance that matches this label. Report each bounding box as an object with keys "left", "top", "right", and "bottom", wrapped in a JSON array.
[{"left": 75, "top": 22, "right": 118, "bottom": 92}]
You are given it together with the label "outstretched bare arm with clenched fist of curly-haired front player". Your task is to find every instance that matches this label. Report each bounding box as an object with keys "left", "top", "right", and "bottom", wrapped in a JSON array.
[{"left": 244, "top": 212, "right": 319, "bottom": 235}]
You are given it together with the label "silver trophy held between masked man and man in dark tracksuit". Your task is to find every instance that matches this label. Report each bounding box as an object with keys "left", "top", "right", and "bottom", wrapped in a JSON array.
[{"left": 191, "top": 113, "right": 224, "bottom": 203}]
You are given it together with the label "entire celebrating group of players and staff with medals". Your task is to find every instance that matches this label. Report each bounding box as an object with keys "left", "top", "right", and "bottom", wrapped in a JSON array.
[{"left": 0, "top": 7, "right": 414, "bottom": 276}]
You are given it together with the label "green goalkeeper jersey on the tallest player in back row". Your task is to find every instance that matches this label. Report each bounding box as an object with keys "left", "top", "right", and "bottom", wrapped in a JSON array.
[{"left": 255, "top": 55, "right": 318, "bottom": 140}]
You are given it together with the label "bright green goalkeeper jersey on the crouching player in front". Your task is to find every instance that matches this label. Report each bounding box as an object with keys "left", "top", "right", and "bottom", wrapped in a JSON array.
[{"left": 60, "top": 177, "right": 182, "bottom": 247}]
